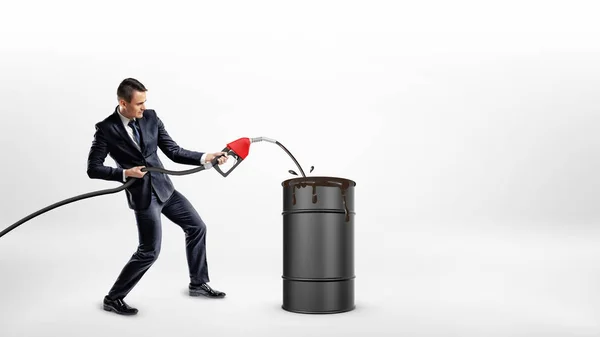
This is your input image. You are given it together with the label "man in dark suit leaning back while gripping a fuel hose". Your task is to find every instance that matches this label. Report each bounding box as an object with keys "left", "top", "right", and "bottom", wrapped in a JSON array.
[{"left": 87, "top": 78, "right": 227, "bottom": 315}]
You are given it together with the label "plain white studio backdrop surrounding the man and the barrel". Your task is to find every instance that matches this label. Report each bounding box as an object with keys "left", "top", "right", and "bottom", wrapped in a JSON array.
[{"left": 0, "top": 1, "right": 600, "bottom": 337}]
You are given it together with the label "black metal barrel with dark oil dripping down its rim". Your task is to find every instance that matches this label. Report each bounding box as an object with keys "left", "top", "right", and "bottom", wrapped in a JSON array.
[{"left": 281, "top": 177, "right": 356, "bottom": 314}]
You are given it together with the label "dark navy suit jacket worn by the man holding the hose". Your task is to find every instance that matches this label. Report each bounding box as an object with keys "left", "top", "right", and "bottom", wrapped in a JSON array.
[{"left": 87, "top": 109, "right": 204, "bottom": 210}]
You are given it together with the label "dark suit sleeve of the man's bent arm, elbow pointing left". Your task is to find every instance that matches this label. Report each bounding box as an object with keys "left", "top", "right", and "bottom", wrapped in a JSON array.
[{"left": 87, "top": 124, "right": 124, "bottom": 182}]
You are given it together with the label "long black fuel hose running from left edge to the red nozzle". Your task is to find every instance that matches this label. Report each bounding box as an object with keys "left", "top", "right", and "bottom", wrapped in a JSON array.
[{"left": 0, "top": 155, "right": 222, "bottom": 237}]
